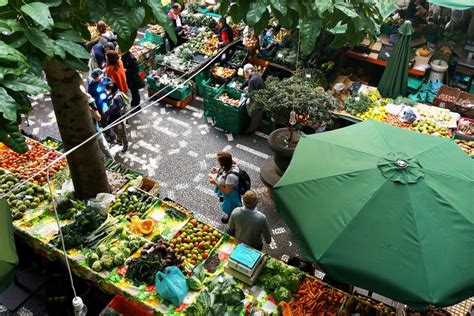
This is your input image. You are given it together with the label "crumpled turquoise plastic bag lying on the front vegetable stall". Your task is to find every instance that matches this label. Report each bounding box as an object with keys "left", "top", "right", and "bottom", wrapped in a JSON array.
[{"left": 155, "top": 266, "right": 189, "bottom": 307}]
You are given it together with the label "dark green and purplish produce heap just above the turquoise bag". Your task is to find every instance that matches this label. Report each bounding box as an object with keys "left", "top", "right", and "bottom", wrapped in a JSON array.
[{"left": 125, "top": 240, "right": 184, "bottom": 285}]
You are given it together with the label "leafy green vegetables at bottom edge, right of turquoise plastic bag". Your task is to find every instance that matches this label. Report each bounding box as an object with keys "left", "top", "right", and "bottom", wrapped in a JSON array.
[{"left": 186, "top": 273, "right": 245, "bottom": 316}]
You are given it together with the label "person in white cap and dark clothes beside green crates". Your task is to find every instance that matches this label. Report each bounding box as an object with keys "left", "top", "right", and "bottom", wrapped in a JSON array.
[{"left": 241, "top": 64, "right": 265, "bottom": 134}]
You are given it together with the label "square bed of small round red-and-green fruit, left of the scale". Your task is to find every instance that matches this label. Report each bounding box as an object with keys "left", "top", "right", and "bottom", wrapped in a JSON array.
[{"left": 170, "top": 219, "right": 222, "bottom": 265}]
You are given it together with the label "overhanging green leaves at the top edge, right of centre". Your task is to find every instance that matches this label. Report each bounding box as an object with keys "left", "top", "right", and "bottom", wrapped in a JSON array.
[{"left": 221, "top": 0, "right": 382, "bottom": 55}]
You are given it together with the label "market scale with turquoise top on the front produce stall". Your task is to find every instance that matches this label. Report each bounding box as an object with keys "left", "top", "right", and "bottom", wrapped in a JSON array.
[{"left": 224, "top": 244, "right": 266, "bottom": 286}]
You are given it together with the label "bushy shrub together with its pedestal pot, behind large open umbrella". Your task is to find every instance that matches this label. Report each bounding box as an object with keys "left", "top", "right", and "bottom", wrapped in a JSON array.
[{"left": 251, "top": 70, "right": 337, "bottom": 183}]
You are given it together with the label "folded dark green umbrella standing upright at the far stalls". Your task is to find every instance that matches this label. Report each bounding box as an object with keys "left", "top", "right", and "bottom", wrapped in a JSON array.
[{"left": 379, "top": 21, "right": 413, "bottom": 99}]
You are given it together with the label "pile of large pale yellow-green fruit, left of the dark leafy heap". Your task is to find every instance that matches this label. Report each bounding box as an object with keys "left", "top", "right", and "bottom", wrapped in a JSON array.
[{"left": 87, "top": 226, "right": 145, "bottom": 272}]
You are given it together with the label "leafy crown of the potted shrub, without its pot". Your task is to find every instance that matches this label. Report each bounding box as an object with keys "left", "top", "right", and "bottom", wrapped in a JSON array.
[{"left": 251, "top": 70, "right": 336, "bottom": 125}]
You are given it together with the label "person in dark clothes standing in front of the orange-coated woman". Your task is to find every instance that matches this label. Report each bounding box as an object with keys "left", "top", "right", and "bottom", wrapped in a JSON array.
[{"left": 106, "top": 82, "right": 128, "bottom": 153}]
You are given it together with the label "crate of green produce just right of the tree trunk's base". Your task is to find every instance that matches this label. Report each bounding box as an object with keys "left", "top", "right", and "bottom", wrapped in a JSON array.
[{"left": 110, "top": 187, "right": 158, "bottom": 217}]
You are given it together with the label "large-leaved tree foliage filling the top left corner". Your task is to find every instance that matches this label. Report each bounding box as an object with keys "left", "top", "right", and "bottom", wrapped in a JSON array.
[{"left": 0, "top": 0, "right": 175, "bottom": 153}]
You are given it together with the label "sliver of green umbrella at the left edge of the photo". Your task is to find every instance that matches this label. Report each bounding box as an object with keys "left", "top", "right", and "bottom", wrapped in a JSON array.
[{"left": 0, "top": 199, "right": 18, "bottom": 293}]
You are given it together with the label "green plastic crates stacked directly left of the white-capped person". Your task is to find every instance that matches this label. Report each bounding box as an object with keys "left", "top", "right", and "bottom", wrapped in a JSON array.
[{"left": 211, "top": 89, "right": 250, "bottom": 134}]
